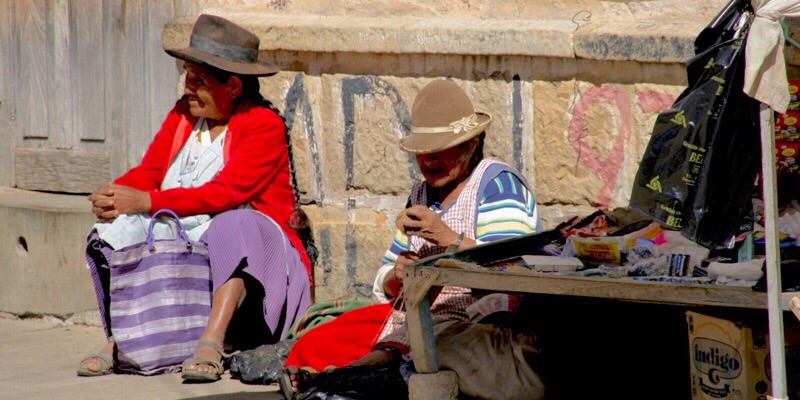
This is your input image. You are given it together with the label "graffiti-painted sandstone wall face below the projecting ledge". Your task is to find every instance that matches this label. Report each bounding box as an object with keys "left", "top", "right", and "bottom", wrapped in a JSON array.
[{"left": 241, "top": 62, "right": 682, "bottom": 298}]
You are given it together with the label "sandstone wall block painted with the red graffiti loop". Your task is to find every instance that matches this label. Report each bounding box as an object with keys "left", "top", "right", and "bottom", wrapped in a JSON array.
[{"left": 534, "top": 81, "right": 682, "bottom": 208}]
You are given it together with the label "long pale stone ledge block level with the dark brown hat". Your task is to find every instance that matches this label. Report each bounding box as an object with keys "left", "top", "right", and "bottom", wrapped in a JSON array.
[{"left": 162, "top": 14, "right": 575, "bottom": 57}]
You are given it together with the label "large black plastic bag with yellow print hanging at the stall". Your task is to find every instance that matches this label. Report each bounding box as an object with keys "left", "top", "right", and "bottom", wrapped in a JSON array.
[{"left": 630, "top": 0, "right": 761, "bottom": 248}]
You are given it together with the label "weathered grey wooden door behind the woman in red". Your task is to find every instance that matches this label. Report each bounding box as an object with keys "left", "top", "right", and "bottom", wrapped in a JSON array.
[{"left": 0, "top": 0, "right": 193, "bottom": 193}]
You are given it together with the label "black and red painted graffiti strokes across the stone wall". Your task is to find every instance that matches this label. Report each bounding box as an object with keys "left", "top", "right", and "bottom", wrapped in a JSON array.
[{"left": 274, "top": 73, "right": 675, "bottom": 296}]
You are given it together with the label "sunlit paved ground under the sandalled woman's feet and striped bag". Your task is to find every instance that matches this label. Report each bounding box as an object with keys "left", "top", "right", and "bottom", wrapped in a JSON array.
[{"left": 0, "top": 319, "right": 283, "bottom": 400}]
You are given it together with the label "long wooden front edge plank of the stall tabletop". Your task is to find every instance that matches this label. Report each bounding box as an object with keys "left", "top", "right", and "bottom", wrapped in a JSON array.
[{"left": 419, "top": 267, "right": 789, "bottom": 310}]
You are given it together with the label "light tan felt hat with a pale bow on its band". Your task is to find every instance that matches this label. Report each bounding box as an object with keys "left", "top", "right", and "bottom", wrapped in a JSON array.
[{"left": 400, "top": 79, "right": 492, "bottom": 154}]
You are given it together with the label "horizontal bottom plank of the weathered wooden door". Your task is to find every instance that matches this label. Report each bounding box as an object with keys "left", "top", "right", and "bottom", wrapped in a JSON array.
[{"left": 14, "top": 149, "right": 111, "bottom": 193}]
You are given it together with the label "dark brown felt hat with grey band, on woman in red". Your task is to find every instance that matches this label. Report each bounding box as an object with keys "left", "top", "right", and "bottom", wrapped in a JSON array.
[{"left": 164, "top": 14, "right": 280, "bottom": 76}]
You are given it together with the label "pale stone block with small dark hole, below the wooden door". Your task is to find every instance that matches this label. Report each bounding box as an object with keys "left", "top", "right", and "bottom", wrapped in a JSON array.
[{"left": 0, "top": 188, "right": 97, "bottom": 315}]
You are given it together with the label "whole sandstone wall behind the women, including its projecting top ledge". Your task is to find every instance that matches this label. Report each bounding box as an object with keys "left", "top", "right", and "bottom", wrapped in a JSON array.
[{"left": 163, "top": 1, "right": 723, "bottom": 300}]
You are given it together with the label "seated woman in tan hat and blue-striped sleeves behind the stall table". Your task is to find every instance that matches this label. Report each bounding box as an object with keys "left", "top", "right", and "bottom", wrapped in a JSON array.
[{"left": 280, "top": 80, "right": 544, "bottom": 399}]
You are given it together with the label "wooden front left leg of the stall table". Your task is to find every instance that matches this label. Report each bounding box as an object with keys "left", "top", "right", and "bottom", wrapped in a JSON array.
[{"left": 403, "top": 265, "right": 439, "bottom": 373}]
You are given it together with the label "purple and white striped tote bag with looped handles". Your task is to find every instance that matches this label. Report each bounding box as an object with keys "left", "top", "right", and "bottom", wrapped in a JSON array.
[{"left": 109, "top": 210, "right": 211, "bottom": 375}]
